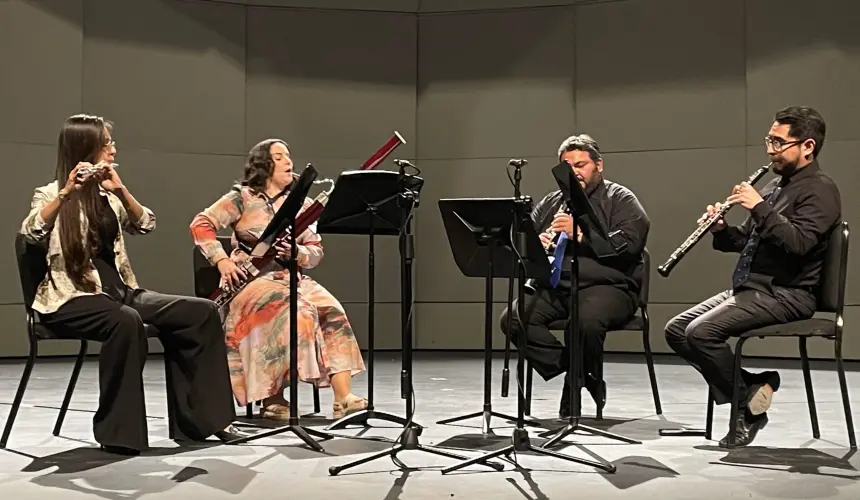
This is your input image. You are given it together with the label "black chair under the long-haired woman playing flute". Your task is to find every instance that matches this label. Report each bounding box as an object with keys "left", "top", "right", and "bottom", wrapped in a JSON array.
[{"left": 0, "top": 233, "right": 163, "bottom": 448}]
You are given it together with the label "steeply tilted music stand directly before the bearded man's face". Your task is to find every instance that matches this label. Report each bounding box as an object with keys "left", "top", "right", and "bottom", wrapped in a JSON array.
[{"left": 541, "top": 162, "right": 642, "bottom": 458}]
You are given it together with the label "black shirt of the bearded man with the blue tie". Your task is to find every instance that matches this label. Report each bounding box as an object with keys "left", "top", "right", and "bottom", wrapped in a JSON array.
[{"left": 532, "top": 180, "right": 651, "bottom": 294}]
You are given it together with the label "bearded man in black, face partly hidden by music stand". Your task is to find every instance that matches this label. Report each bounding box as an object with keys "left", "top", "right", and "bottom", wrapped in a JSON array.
[{"left": 501, "top": 134, "right": 650, "bottom": 418}]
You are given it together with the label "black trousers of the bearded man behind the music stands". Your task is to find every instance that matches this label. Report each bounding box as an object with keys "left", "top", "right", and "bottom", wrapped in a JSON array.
[{"left": 501, "top": 285, "right": 636, "bottom": 380}]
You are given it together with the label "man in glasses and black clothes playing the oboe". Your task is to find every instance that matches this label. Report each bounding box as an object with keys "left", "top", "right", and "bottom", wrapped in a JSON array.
[{"left": 666, "top": 106, "right": 841, "bottom": 447}]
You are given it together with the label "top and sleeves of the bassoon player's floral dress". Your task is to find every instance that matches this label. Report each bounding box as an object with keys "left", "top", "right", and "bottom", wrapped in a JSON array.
[{"left": 190, "top": 186, "right": 323, "bottom": 278}]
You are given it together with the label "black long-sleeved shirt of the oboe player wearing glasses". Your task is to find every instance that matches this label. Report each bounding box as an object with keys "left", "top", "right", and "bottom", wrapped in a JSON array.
[{"left": 713, "top": 161, "right": 842, "bottom": 291}]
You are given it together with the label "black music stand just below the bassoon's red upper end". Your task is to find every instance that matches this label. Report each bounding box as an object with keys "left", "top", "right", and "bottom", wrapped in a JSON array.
[{"left": 317, "top": 170, "right": 416, "bottom": 430}]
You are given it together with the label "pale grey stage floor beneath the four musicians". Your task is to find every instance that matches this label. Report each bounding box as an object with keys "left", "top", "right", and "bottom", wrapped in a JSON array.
[{"left": 0, "top": 353, "right": 860, "bottom": 500}]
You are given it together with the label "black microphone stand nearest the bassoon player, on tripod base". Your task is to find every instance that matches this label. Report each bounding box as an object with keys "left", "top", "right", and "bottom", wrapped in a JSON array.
[{"left": 328, "top": 165, "right": 503, "bottom": 476}]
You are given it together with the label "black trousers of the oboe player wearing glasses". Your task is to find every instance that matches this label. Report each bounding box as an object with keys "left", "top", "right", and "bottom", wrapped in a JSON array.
[{"left": 666, "top": 287, "right": 815, "bottom": 405}]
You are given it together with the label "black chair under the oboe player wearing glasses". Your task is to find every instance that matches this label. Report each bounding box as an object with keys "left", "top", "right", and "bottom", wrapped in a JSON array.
[{"left": 720, "top": 222, "right": 857, "bottom": 449}]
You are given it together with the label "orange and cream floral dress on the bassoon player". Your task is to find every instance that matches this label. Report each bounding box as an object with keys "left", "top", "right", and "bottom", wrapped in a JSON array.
[{"left": 190, "top": 186, "right": 365, "bottom": 405}]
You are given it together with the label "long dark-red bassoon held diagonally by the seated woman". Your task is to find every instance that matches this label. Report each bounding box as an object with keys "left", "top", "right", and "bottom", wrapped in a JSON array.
[{"left": 209, "top": 131, "right": 406, "bottom": 308}]
